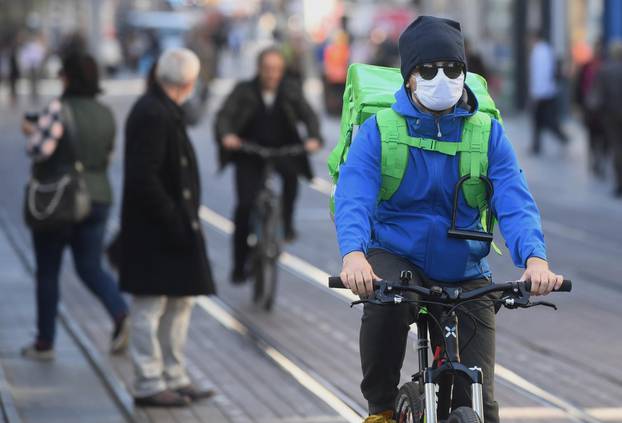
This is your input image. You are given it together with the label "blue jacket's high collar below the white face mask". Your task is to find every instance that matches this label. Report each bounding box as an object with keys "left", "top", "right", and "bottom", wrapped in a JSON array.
[{"left": 392, "top": 84, "right": 478, "bottom": 142}]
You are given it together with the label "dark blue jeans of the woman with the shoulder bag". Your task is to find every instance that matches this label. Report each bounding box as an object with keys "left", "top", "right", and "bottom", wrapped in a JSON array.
[{"left": 32, "top": 204, "right": 128, "bottom": 344}]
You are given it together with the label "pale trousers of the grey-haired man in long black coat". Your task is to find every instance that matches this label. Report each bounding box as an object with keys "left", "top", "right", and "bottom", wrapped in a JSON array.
[{"left": 130, "top": 296, "right": 194, "bottom": 398}]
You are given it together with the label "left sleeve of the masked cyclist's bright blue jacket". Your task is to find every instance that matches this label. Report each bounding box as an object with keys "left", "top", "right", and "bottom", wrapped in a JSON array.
[{"left": 335, "top": 117, "right": 381, "bottom": 256}]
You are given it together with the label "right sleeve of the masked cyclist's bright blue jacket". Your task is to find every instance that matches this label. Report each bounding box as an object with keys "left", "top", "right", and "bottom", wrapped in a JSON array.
[{"left": 488, "top": 120, "right": 546, "bottom": 267}]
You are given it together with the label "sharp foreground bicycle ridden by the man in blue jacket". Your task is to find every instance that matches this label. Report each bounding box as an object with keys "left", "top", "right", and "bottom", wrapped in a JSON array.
[{"left": 328, "top": 272, "right": 572, "bottom": 423}]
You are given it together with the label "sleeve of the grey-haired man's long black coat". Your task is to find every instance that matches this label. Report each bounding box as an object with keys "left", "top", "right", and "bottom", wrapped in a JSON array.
[{"left": 125, "top": 113, "right": 189, "bottom": 246}]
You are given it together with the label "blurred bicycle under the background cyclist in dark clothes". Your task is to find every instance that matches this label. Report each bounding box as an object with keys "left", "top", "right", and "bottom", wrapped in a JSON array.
[{"left": 240, "top": 142, "right": 304, "bottom": 310}]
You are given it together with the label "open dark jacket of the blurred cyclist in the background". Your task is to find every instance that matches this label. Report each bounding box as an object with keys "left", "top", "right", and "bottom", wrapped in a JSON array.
[{"left": 214, "top": 78, "right": 322, "bottom": 179}]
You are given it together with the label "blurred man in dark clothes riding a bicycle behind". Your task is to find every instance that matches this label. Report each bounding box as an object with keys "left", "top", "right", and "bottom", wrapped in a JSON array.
[{"left": 215, "top": 47, "right": 322, "bottom": 283}]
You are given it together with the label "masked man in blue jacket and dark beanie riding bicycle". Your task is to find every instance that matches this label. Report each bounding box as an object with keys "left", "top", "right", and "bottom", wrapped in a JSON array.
[{"left": 335, "top": 16, "right": 563, "bottom": 423}]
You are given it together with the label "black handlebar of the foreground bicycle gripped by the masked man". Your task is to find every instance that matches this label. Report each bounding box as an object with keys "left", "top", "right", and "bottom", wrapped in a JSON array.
[{"left": 328, "top": 276, "right": 572, "bottom": 303}]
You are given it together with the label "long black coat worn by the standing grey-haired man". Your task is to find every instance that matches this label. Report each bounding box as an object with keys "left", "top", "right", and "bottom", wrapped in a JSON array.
[{"left": 119, "top": 85, "right": 214, "bottom": 296}]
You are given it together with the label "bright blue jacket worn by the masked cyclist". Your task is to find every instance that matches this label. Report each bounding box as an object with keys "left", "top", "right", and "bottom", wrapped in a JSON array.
[{"left": 335, "top": 87, "right": 546, "bottom": 282}]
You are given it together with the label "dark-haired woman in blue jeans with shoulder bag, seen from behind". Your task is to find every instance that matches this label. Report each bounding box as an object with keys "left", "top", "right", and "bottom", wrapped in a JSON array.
[{"left": 22, "top": 54, "right": 128, "bottom": 359}]
